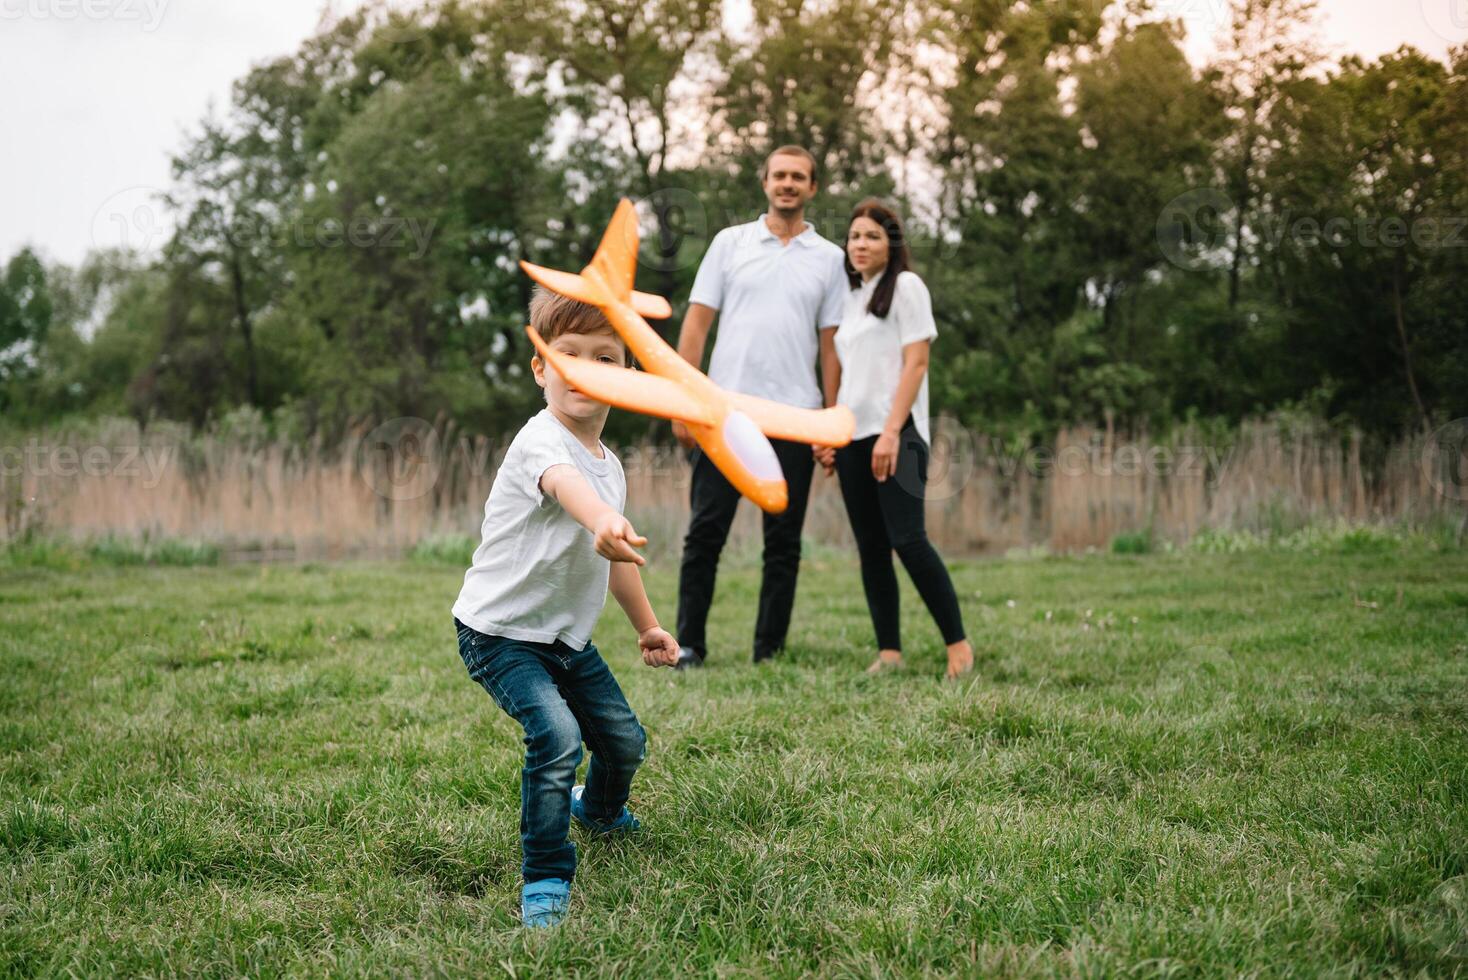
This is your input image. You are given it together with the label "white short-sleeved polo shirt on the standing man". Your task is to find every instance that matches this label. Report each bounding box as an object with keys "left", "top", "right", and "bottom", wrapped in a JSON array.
[{"left": 688, "top": 216, "right": 850, "bottom": 408}]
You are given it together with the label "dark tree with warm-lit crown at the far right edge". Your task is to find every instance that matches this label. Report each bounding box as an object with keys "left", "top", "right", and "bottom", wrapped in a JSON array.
[{"left": 1267, "top": 48, "right": 1468, "bottom": 430}]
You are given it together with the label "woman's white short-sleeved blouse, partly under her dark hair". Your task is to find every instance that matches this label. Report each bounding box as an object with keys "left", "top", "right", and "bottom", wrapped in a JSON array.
[{"left": 835, "top": 271, "right": 938, "bottom": 445}]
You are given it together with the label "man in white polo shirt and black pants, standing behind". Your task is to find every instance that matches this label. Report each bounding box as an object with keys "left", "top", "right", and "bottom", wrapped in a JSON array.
[{"left": 672, "top": 147, "right": 847, "bottom": 668}]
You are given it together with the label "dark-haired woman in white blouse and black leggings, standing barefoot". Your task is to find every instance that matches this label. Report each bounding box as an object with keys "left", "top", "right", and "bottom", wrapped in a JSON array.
[{"left": 816, "top": 198, "right": 973, "bottom": 681}]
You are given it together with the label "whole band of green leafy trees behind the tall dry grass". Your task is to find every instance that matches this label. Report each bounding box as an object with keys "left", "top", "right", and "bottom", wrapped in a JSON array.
[{"left": 0, "top": 0, "right": 1468, "bottom": 442}]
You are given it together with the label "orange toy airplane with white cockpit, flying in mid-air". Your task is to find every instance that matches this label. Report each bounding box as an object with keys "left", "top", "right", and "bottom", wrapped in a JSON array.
[{"left": 520, "top": 198, "right": 856, "bottom": 513}]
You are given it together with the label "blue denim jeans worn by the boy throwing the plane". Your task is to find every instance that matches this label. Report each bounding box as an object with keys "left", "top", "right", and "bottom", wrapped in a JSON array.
[{"left": 454, "top": 619, "right": 647, "bottom": 885}]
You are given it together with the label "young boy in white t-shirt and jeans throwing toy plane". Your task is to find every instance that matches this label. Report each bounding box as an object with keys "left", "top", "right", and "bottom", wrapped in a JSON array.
[{"left": 454, "top": 288, "right": 678, "bottom": 927}]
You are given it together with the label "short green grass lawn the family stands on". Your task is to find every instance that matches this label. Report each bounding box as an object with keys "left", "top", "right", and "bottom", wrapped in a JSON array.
[{"left": 0, "top": 550, "right": 1468, "bottom": 977}]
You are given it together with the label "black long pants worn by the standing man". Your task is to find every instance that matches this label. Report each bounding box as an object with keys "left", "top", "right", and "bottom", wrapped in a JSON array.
[{"left": 678, "top": 439, "right": 815, "bottom": 660}]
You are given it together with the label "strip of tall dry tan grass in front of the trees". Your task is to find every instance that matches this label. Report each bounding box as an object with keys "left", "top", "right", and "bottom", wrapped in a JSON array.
[{"left": 0, "top": 418, "right": 1464, "bottom": 557}]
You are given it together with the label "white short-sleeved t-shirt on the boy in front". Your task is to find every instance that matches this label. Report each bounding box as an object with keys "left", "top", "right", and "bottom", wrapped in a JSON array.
[{"left": 454, "top": 408, "right": 627, "bottom": 650}]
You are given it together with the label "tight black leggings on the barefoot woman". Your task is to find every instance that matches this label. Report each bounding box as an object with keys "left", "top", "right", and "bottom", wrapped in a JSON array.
[{"left": 835, "top": 418, "right": 964, "bottom": 650}]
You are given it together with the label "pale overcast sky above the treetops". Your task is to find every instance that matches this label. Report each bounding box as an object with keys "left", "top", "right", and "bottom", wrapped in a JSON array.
[{"left": 0, "top": 0, "right": 1468, "bottom": 263}]
